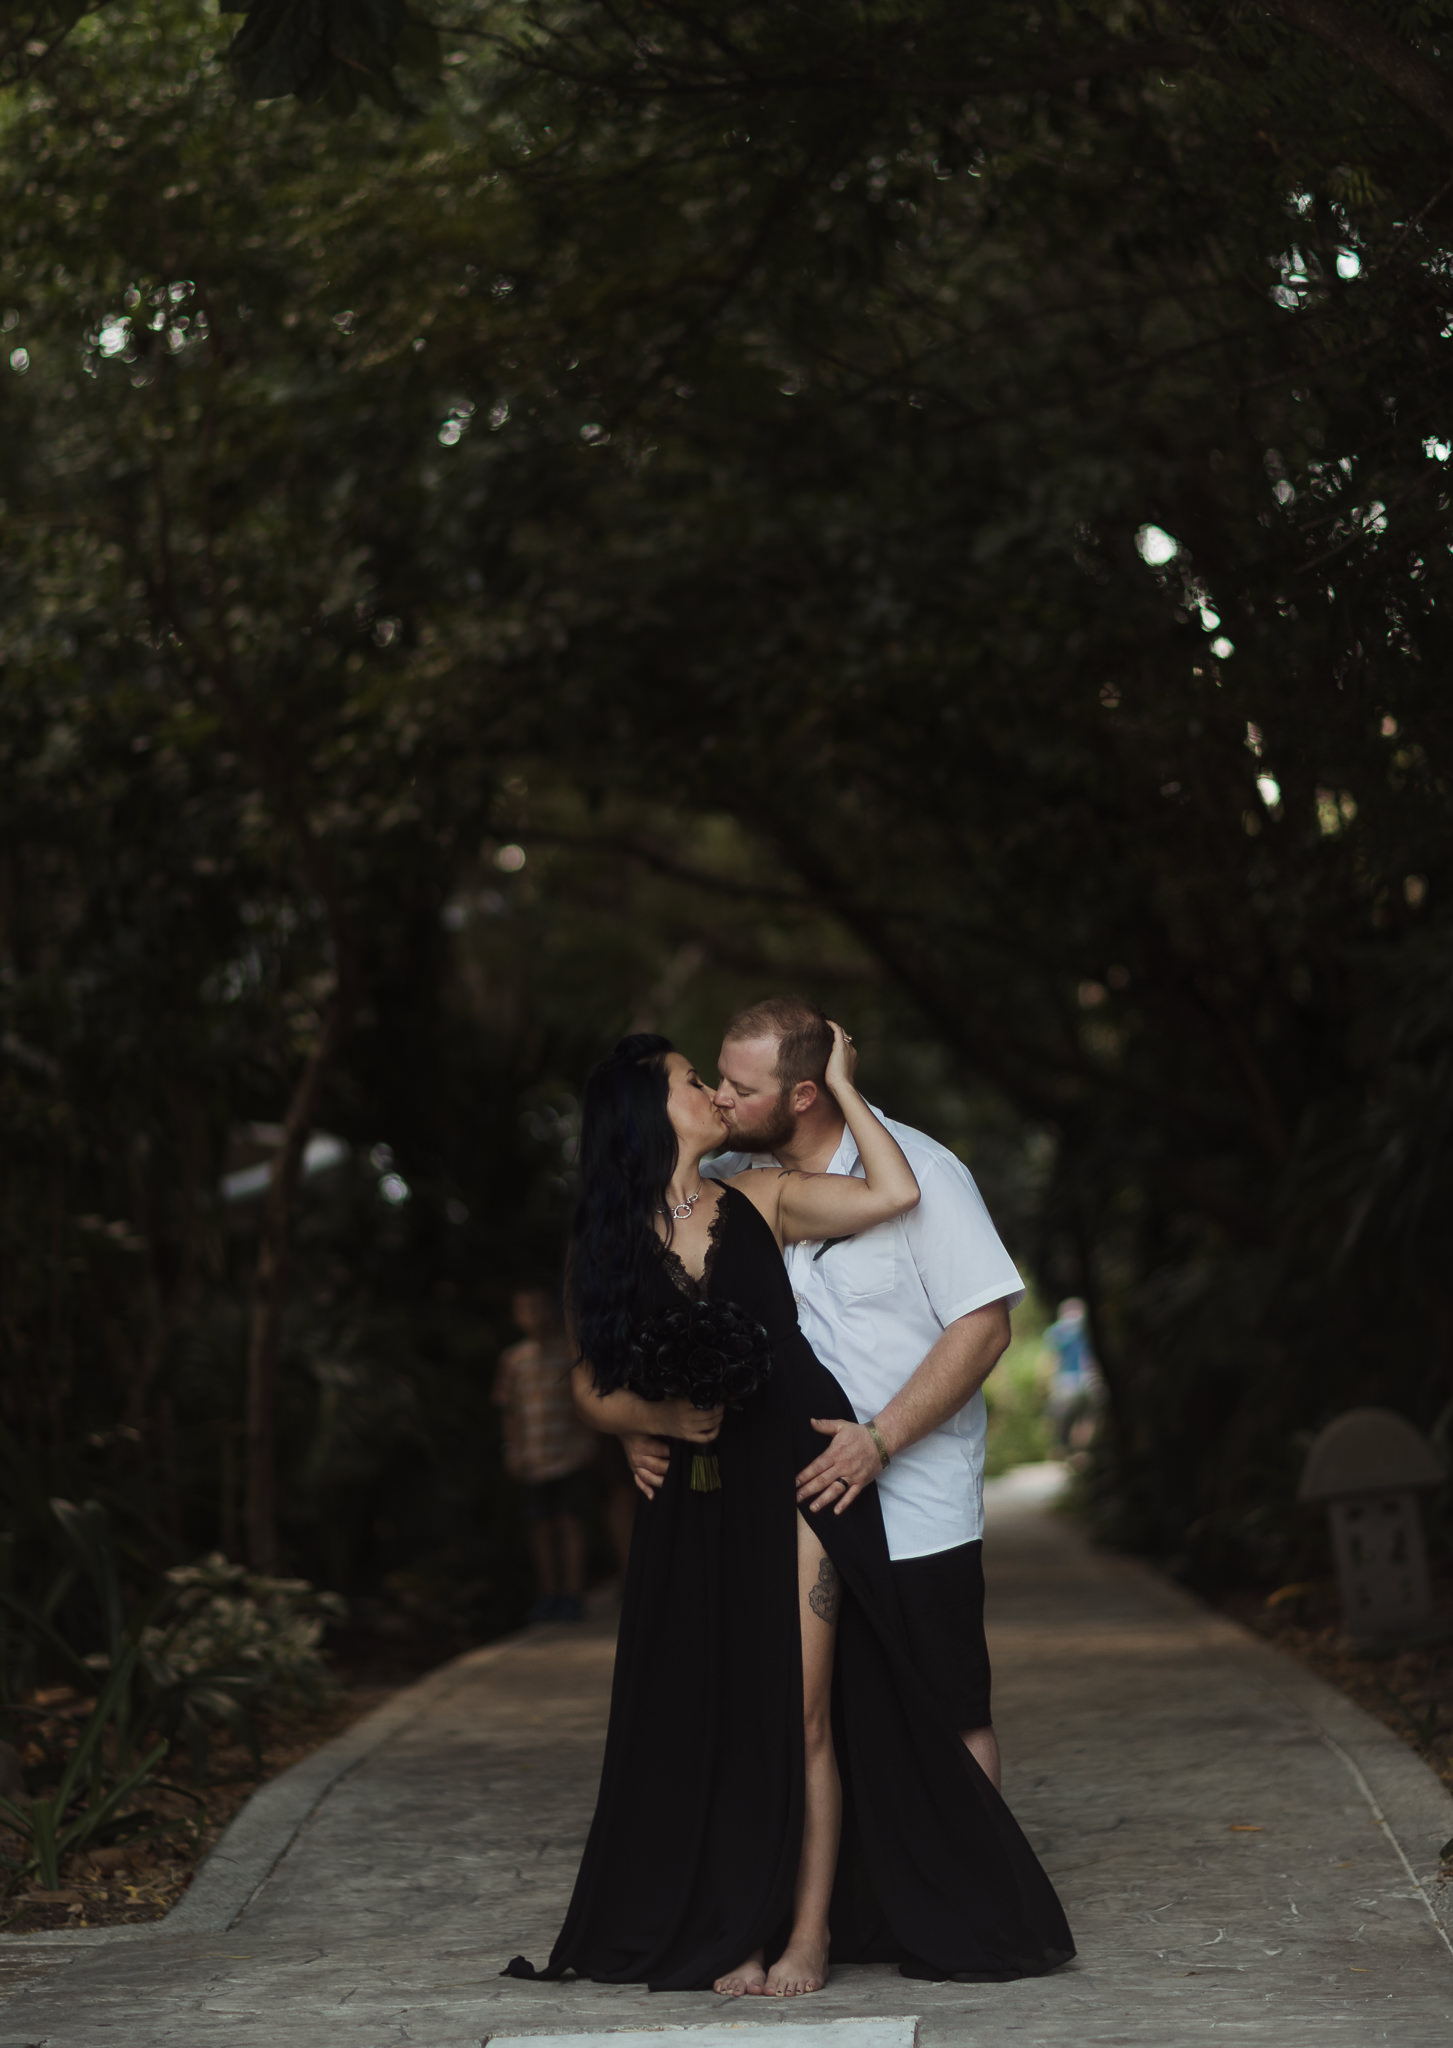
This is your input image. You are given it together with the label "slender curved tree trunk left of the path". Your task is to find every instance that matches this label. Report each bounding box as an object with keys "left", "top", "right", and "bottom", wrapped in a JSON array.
[{"left": 244, "top": 983, "right": 355, "bottom": 1573}]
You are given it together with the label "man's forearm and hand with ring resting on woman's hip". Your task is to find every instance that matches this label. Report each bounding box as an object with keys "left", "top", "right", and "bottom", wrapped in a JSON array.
[{"left": 797, "top": 1300, "right": 1010, "bottom": 1513}]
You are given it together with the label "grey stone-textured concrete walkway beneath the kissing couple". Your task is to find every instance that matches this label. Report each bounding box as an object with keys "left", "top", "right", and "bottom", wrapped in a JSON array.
[{"left": 0, "top": 1470, "right": 1453, "bottom": 2048}]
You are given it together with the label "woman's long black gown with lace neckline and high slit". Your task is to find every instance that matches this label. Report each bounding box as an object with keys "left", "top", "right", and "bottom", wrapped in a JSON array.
[{"left": 504, "top": 1188, "right": 1074, "bottom": 1991}]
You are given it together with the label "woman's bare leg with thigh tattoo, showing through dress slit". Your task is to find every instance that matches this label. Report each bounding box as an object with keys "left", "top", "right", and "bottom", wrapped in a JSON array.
[{"left": 766, "top": 1513, "right": 842, "bottom": 1999}]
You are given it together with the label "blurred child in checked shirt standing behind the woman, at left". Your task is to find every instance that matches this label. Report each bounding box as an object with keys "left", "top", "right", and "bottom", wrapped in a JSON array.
[{"left": 494, "top": 1286, "right": 596, "bottom": 1622}]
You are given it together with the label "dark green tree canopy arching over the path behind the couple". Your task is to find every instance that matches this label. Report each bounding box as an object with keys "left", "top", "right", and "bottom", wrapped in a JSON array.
[{"left": 0, "top": 0, "right": 1453, "bottom": 1597}]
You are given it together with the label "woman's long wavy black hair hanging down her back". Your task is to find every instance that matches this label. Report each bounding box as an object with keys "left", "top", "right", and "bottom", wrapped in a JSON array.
[{"left": 566, "top": 1032, "right": 678, "bottom": 1395}]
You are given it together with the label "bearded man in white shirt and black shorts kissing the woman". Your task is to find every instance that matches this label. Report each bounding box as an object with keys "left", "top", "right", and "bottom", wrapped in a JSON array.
[{"left": 627, "top": 997, "right": 1025, "bottom": 1784}]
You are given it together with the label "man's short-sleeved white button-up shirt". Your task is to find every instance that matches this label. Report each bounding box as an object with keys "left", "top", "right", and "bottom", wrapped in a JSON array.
[{"left": 707, "top": 1116, "right": 1025, "bottom": 1556}]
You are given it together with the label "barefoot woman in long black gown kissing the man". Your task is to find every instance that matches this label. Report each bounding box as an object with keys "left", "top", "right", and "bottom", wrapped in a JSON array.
[{"left": 508, "top": 1026, "right": 1074, "bottom": 1995}]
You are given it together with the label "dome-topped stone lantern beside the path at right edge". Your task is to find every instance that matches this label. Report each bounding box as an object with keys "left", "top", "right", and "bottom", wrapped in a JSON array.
[{"left": 1297, "top": 1409, "right": 1445, "bottom": 1649}]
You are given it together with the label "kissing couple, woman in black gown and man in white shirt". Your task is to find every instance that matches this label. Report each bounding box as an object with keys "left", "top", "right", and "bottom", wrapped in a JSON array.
[{"left": 504, "top": 997, "right": 1074, "bottom": 1997}]
